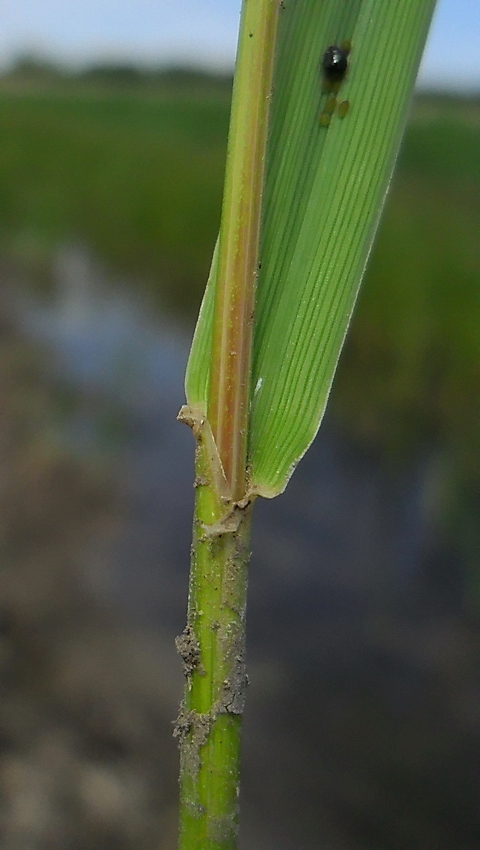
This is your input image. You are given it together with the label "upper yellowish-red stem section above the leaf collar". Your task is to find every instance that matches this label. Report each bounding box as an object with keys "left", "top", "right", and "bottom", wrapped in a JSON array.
[{"left": 208, "top": 0, "right": 279, "bottom": 501}]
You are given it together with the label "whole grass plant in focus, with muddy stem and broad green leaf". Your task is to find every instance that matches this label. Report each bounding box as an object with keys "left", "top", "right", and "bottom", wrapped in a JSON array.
[{"left": 176, "top": 0, "right": 434, "bottom": 850}]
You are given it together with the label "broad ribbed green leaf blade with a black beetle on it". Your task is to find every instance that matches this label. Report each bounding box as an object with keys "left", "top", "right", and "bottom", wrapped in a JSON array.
[{"left": 250, "top": 0, "right": 434, "bottom": 496}]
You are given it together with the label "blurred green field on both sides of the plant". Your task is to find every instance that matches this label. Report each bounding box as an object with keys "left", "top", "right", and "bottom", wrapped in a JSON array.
[{"left": 0, "top": 67, "right": 480, "bottom": 486}]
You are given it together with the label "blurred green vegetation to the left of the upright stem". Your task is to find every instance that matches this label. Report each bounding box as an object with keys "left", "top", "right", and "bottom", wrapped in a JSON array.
[{"left": 0, "top": 68, "right": 230, "bottom": 311}]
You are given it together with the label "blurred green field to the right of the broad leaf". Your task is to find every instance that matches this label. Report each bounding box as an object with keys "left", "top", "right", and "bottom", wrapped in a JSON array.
[{"left": 337, "top": 93, "right": 480, "bottom": 460}]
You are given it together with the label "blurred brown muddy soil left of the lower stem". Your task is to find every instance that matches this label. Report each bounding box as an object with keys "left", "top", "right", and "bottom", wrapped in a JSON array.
[{"left": 0, "top": 323, "right": 177, "bottom": 850}]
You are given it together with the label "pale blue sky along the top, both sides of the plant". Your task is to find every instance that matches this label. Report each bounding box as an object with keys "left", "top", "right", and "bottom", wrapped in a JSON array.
[{"left": 0, "top": 0, "right": 480, "bottom": 90}]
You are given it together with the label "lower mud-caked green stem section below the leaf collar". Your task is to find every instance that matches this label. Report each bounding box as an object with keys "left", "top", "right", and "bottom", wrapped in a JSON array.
[{"left": 176, "top": 438, "right": 252, "bottom": 850}]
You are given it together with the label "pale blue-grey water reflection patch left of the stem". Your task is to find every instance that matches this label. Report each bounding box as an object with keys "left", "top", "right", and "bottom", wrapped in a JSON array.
[{"left": 18, "top": 244, "right": 189, "bottom": 410}]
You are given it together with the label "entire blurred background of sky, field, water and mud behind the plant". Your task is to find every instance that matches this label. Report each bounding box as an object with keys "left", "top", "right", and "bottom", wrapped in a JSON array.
[{"left": 0, "top": 0, "right": 480, "bottom": 850}]
